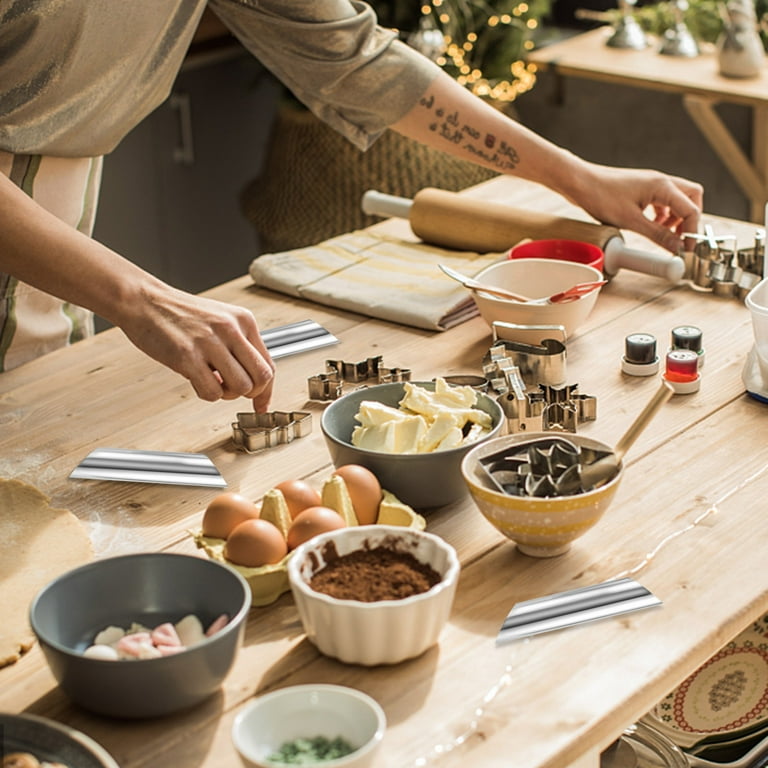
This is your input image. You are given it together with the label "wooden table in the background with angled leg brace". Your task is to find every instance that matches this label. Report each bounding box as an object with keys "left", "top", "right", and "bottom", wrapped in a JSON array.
[{"left": 527, "top": 27, "right": 768, "bottom": 222}]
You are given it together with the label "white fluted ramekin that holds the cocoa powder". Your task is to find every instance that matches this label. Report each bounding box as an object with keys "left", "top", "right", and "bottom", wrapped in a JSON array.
[{"left": 288, "top": 525, "right": 459, "bottom": 666}]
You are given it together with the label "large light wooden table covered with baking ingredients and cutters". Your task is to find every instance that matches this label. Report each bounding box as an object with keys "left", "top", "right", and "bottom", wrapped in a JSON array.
[{"left": 0, "top": 178, "right": 768, "bottom": 768}]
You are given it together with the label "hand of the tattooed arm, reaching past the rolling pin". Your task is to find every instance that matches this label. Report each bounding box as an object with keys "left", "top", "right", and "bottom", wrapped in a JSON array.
[{"left": 569, "top": 163, "right": 704, "bottom": 253}]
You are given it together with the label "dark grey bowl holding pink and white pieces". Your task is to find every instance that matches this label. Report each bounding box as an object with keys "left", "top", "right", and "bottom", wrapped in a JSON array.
[{"left": 30, "top": 553, "right": 251, "bottom": 718}]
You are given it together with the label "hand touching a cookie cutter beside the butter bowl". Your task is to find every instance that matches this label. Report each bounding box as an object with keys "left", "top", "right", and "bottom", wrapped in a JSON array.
[{"left": 118, "top": 284, "right": 275, "bottom": 413}]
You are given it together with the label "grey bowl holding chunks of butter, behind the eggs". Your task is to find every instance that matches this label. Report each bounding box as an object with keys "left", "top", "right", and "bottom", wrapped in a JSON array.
[{"left": 320, "top": 382, "right": 504, "bottom": 509}]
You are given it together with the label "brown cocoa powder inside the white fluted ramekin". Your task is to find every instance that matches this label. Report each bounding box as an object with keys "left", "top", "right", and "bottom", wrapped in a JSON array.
[{"left": 309, "top": 547, "right": 440, "bottom": 603}]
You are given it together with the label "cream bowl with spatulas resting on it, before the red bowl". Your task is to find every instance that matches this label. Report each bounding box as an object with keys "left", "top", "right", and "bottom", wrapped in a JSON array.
[{"left": 474, "top": 259, "right": 603, "bottom": 338}]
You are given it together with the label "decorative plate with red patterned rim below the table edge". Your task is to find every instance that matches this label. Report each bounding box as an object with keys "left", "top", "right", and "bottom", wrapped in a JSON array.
[{"left": 645, "top": 616, "right": 768, "bottom": 747}]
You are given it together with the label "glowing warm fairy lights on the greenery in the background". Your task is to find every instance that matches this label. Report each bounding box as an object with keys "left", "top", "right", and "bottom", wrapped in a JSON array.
[{"left": 421, "top": 0, "right": 539, "bottom": 103}]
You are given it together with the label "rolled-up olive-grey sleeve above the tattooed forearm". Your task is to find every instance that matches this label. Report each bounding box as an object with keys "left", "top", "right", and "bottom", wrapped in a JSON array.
[{"left": 210, "top": 0, "right": 439, "bottom": 149}]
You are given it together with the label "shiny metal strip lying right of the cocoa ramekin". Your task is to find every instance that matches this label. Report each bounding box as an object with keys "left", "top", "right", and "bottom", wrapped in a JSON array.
[{"left": 496, "top": 578, "right": 661, "bottom": 645}]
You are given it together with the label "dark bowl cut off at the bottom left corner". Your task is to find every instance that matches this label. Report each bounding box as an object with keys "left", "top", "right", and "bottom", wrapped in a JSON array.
[{"left": 0, "top": 713, "right": 119, "bottom": 768}]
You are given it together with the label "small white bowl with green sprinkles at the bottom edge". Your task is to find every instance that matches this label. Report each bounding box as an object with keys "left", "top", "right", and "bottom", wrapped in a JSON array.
[{"left": 232, "top": 684, "right": 387, "bottom": 768}]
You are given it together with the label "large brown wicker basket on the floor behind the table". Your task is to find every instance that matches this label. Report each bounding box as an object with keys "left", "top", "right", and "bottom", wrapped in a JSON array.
[{"left": 242, "top": 105, "right": 496, "bottom": 253}]
